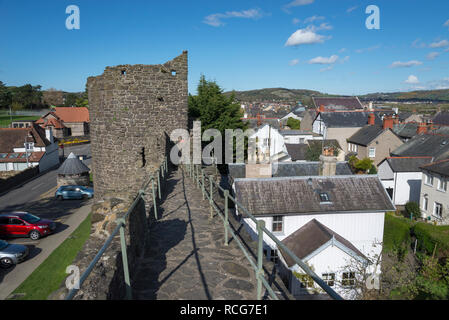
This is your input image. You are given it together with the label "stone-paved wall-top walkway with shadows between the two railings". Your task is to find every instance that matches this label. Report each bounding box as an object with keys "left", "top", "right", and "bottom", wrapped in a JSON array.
[{"left": 132, "top": 169, "right": 256, "bottom": 300}]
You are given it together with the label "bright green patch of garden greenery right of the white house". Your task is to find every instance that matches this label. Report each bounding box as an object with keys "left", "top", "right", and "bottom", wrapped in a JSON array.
[{"left": 383, "top": 213, "right": 412, "bottom": 252}]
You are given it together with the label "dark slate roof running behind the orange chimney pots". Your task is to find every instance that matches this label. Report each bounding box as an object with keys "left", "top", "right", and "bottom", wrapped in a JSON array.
[{"left": 320, "top": 111, "right": 394, "bottom": 128}]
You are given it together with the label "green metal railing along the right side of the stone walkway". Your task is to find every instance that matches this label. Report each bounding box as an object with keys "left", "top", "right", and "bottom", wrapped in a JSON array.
[{"left": 183, "top": 164, "right": 343, "bottom": 300}]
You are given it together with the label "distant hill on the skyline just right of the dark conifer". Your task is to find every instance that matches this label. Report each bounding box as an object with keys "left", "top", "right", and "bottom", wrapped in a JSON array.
[{"left": 225, "top": 88, "right": 324, "bottom": 104}]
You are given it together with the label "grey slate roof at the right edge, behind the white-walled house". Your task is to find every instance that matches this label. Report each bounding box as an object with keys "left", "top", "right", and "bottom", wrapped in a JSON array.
[{"left": 391, "top": 134, "right": 449, "bottom": 160}]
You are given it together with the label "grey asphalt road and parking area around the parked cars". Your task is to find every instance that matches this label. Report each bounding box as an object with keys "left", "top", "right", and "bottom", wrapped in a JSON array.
[{"left": 0, "top": 144, "right": 92, "bottom": 300}]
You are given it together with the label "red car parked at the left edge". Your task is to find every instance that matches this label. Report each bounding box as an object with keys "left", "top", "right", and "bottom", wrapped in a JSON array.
[{"left": 0, "top": 212, "right": 56, "bottom": 240}]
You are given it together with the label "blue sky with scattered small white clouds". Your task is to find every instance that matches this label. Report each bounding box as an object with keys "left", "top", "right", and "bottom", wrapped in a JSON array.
[{"left": 0, "top": 0, "right": 449, "bottom": 94}]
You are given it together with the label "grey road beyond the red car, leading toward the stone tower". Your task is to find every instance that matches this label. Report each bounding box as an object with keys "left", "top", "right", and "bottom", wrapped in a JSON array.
[{"left": 0, "top": 144, "right": 91, "bottom": 211}]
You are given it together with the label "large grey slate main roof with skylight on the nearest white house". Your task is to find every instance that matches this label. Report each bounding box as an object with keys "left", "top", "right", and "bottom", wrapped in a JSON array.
[{"left": 234, "top": 175, "right": 396, "bottom": 215}]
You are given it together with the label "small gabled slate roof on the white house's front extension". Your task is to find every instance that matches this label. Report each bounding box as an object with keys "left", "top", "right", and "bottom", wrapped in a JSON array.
[{"left": 280, "top": 219, "right": 366, "bottom": 267}]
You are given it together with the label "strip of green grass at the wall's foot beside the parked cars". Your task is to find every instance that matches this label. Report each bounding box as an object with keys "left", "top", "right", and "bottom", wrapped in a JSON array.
[{"left": 12, "top": 214, "right": 92, "bottom": 300}]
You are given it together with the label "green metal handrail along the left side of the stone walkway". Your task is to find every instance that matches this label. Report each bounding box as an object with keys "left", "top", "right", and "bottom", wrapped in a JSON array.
[{"left": 65, "top": 157, "right": 168, "bottom": 300}]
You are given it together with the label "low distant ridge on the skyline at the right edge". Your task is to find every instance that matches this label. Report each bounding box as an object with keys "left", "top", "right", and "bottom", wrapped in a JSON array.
[{"left": 359, "top": 89, "right": 449, "bottom": 102}]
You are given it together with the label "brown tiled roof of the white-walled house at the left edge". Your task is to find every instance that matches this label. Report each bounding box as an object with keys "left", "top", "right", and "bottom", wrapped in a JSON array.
[{"left": 0, "top": 124, "right": 50, "bottom": 153}]
